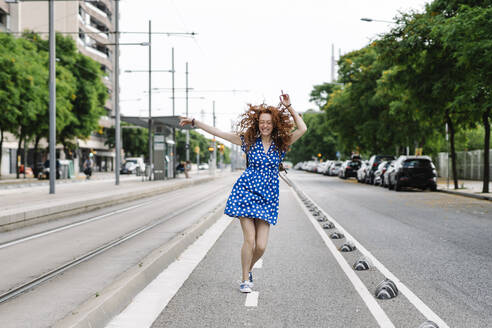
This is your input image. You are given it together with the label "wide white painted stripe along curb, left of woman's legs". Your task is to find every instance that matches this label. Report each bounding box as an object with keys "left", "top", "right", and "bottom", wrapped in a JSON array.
[{"left": 106, "top": 215, "right": 233, "bottom": 328}]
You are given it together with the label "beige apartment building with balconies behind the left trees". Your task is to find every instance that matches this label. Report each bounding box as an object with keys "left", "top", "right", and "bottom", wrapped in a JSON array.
[{"left": 0, "top": 0, "right": 115, "bottom": 174}]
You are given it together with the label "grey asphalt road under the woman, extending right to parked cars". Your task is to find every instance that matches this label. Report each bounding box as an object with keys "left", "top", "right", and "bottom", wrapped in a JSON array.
[{"left": 148, "top": 171, "right": 492, "bottom": 328}]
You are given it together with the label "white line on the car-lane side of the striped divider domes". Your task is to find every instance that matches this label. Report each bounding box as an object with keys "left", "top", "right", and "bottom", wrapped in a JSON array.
[{"left": 294, "top": 187, "right": 449, "bottom": 328}]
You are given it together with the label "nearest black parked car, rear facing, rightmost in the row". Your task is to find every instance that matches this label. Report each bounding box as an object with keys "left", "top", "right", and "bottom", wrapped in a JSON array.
[{"left": 388, "top": 156, "right": 437, "bottom": 191}]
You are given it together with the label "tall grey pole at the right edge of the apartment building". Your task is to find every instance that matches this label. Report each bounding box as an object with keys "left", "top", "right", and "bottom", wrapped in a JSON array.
[{"left": 114, "top": 1, "right": 121, "bottom": 186}]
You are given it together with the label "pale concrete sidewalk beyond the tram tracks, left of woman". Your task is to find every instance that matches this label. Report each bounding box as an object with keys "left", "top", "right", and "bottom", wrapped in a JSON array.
[{"left": 0, "top": 171, "right": 231, "bottom": 231}]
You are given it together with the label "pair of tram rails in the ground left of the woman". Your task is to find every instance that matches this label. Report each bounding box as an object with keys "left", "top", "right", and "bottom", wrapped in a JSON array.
[{"left": 0, "top": 186, "right": 225, "bottom": 304}]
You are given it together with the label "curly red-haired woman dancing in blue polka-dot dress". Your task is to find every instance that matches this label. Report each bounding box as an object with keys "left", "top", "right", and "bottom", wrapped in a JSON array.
[{"left": 180, "top": 92, "right": 307, "bottom": 293}]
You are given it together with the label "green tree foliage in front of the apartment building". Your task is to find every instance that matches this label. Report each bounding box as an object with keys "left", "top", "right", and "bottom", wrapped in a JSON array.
[{"left": 0, "top": 32, "right": 108, "bottom": 177}]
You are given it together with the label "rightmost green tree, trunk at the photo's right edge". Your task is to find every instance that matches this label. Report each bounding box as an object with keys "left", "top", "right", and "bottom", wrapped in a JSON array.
[{"left": 433, "top": 5, "right": 492, "bottom": 193}]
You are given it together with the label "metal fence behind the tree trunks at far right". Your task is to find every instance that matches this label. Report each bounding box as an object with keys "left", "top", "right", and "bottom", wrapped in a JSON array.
[{"left": 437, "top": 149, "right": 492, "bottom": 180}]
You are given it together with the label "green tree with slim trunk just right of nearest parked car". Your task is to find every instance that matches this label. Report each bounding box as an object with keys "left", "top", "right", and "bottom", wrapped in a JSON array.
[{"left": 376, "top": 6, "right": 475, "bottom": 188}]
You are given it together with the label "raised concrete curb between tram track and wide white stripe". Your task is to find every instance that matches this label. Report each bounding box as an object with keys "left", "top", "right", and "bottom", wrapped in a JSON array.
[{"left": 53, "top": 205, "right": 229, "bottom": 328}]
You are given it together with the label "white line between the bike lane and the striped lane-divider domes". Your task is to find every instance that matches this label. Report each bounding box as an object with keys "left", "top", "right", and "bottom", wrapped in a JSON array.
[{"left": 292, "top": 190, "right": 395, "bottom": 328}]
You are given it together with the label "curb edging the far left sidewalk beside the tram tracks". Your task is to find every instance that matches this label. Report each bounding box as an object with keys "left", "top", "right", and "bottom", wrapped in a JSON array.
[{"left": 0, "top": 175, "right": 221, "bottom": 232}]
